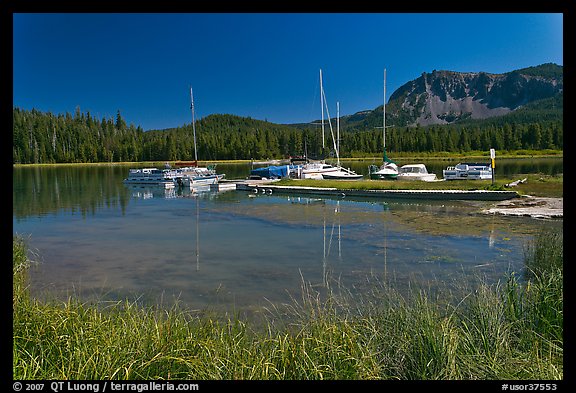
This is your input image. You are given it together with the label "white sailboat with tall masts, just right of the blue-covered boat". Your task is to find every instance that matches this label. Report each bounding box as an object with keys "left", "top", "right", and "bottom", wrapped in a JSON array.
[{"left": 295, "top": 69, "right": 363, "bottom": 180}]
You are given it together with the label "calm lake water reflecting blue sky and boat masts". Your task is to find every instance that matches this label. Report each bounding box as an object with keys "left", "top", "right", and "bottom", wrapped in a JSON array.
[{"left": 13, "top": 159, "right": 563, "bottom": 312}]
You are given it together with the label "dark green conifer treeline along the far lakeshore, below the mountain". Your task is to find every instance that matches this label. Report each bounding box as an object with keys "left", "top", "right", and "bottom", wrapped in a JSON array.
[{"left": 12, "top": 108, "right": 564, "bottom": 164}]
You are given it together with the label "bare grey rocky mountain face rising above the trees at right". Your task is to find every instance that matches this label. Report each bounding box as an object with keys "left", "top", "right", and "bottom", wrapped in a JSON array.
[{"left": 388, "top": 64, "right": 563, "bottom": 126}]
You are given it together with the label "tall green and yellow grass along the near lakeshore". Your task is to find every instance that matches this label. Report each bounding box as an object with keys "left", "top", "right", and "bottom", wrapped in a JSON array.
[{"left": 13, "top": 228, "right": 563, "bottom": 380}]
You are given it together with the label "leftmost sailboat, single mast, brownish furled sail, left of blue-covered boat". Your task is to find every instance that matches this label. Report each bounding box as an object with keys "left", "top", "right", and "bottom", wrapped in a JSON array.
[{"left": 173, "top": 86, "right": 225, "bottom": 187}]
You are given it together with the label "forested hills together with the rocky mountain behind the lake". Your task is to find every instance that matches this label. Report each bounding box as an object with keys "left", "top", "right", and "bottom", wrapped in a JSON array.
[{"left": 12, "top": 63, "right": 564, "bottom": 164}]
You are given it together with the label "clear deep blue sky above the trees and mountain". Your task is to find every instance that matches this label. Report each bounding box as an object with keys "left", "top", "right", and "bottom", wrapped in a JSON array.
[{"left": 13, "top": 13, "right": 563, "bottom": 130}]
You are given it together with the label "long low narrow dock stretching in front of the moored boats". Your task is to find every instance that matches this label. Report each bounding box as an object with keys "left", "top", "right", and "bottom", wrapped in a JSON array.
[{"left": 235, "top": 181, "right": 519, "bottom": 201}]
